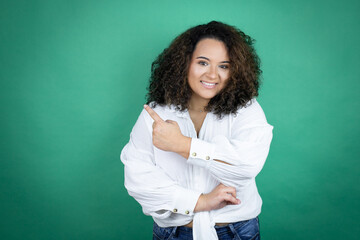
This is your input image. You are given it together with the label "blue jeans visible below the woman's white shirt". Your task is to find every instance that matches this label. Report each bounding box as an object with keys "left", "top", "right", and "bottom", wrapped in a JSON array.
[{"left": 153, "top": 217, "right": 260, "bottom": 240}]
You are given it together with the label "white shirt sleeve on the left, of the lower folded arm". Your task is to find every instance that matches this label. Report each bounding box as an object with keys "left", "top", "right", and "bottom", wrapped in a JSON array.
[{"left": 121, "top": 110, "right": 201, "bottom": 219}]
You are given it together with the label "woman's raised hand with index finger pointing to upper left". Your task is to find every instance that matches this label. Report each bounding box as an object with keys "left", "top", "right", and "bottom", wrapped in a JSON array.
[{"left": 144, "top": 105, "right": 191, "bottom": 158}]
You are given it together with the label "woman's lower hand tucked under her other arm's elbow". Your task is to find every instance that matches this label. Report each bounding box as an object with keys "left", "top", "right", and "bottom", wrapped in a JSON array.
[{"left": 194, "top": 183, "right": 240, "bottom": 212}]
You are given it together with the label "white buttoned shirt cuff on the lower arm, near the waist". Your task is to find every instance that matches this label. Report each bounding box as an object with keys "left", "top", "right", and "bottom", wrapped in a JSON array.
[{"left": 172, "top": 188, "right": 201, "bottom": 216}]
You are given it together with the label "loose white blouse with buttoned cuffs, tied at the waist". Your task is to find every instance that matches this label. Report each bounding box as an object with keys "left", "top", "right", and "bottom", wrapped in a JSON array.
[{"left": 121, "top": 99, "right": 273, "bottom": 240}]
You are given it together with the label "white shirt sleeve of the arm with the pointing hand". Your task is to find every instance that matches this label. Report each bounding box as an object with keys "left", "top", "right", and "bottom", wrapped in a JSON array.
[{"left": 188, "top": 101, "right": 273, "bottom": 188}]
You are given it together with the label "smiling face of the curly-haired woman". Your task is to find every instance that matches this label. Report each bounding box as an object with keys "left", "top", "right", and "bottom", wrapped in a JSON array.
[{"left": 188, "top": 38, "right": 230, "bottom": 104}]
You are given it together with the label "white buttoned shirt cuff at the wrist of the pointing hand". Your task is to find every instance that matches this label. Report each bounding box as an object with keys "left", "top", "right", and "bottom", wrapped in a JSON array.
[{"left": 188, "top": 138, "right": 215, "bottom": 167}]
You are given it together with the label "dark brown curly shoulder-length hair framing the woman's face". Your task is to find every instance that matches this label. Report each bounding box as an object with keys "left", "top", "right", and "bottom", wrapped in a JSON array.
[{"left": 147, "top": 21, "right": 262, "bottom": 118}]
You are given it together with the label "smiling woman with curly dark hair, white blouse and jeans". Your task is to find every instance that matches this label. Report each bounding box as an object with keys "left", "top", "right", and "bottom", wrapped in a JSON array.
[{"left": 121, "top": 21, "right": 273, "bottom": 240}]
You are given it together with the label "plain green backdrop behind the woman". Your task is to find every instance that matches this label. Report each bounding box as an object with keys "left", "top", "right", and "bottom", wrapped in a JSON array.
[{"left": 0, "top": 0, "right": 360, "bottom": 240}]
